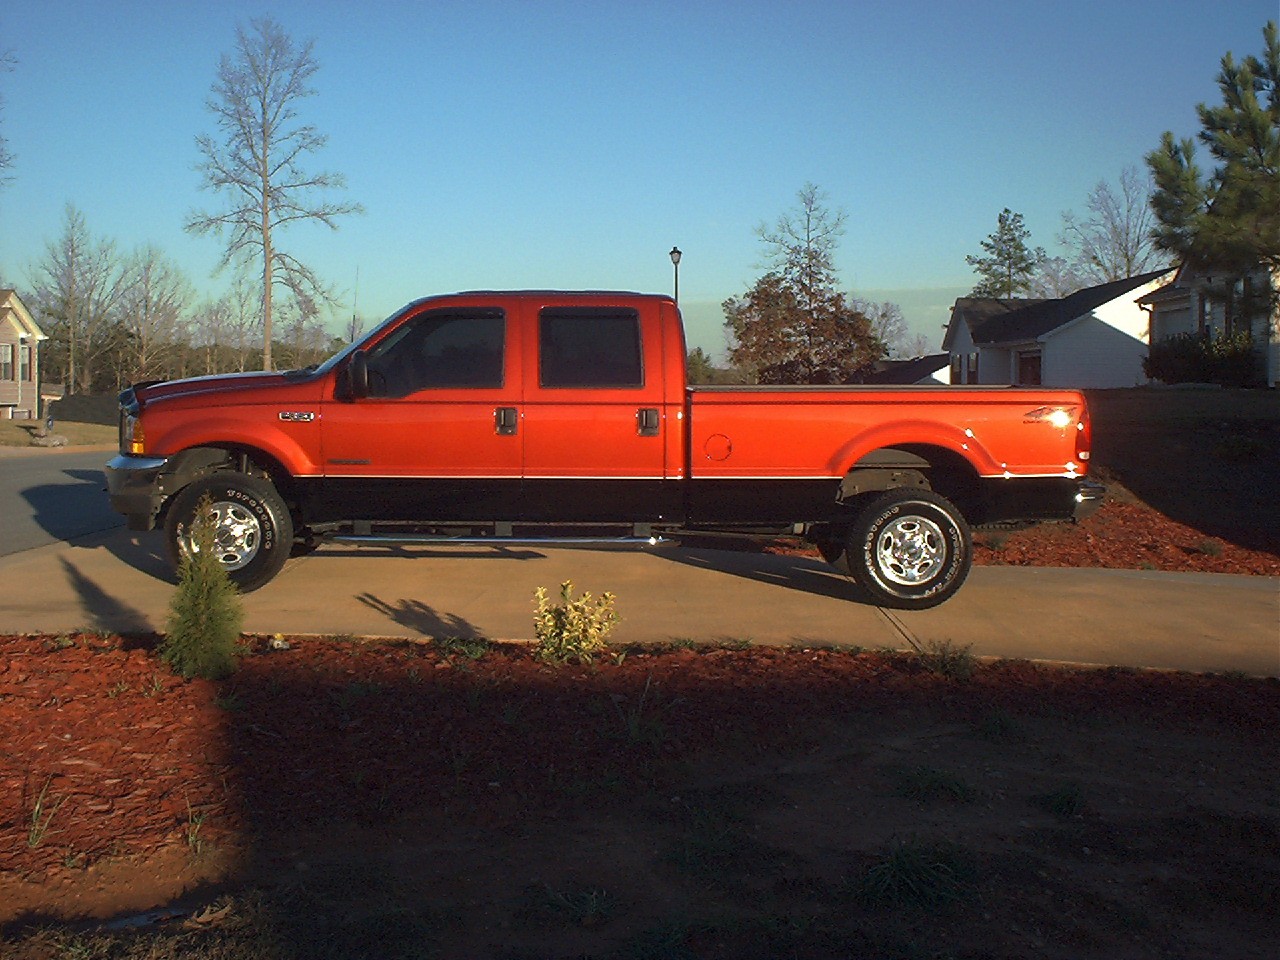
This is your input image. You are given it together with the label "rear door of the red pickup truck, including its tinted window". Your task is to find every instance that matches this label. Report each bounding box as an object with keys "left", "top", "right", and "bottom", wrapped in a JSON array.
[{"left": 522, "top": 305, "right": 681, "bottom": 522}]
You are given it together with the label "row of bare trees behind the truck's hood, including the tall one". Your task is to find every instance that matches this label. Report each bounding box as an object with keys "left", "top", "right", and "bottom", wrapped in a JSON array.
[{"left": 0, "top": 17, "right": 361, "bottom": 393}]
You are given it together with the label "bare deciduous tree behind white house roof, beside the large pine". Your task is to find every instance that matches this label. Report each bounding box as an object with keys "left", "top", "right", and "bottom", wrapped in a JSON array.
[{"left": 1057, "top": 166, "right": 1164, "bottom": 283}]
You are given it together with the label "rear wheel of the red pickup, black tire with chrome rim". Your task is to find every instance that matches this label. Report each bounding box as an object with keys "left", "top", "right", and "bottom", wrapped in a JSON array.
[{"left": 845, "top": 489, "right": 973, "bottom": 611}]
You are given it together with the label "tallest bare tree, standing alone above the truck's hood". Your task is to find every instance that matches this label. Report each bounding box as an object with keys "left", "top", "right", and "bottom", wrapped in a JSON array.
[{"left": 187, "top": 18, "right": 361, "bottom": 370}]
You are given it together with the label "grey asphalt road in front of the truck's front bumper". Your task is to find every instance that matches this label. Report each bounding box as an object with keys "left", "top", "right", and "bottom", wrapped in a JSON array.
[{"left": 0, "top": 448, "right": 124, "bottom": 557}]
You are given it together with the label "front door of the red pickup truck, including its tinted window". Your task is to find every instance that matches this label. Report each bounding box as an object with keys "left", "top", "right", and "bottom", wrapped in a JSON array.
[{"left": 321, "top": 306, "right": 522, "bottom": 521}]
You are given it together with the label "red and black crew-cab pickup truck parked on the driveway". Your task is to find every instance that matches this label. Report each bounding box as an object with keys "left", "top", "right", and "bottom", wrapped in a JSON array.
[{"left": 106, "top": 292, "right": 1101, "bottom": 609}]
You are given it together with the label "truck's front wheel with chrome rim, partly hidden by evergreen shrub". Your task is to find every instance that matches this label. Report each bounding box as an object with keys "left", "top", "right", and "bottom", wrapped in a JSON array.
[{"left": 164, "top": 474, "right": 293, "bottom": 594}]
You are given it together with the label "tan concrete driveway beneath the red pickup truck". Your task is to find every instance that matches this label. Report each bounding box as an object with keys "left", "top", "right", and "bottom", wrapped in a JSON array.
[{"left": 0, "top": 530, "right": 1280, "bottom": 676}]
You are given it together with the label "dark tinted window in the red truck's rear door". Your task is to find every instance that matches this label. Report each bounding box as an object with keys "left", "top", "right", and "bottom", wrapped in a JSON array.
[{"left": 538, "top": 307, "right": 644, "bottom": 388}]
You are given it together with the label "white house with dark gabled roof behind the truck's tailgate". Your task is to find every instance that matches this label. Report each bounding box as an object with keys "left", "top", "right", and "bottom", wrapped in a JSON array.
[{"left": 942, "top": 269, "right": 1174, "bottom": 388}]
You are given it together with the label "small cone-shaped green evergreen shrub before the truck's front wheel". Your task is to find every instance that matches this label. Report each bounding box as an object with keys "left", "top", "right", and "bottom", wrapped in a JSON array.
[{"left": 160, "top": 495, "right": 244, "bottom": 680}]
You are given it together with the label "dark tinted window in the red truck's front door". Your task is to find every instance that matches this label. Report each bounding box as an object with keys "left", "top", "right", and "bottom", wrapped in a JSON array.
[{"left": 369, "top": 308, "right": 507, "bottom": 398}]
